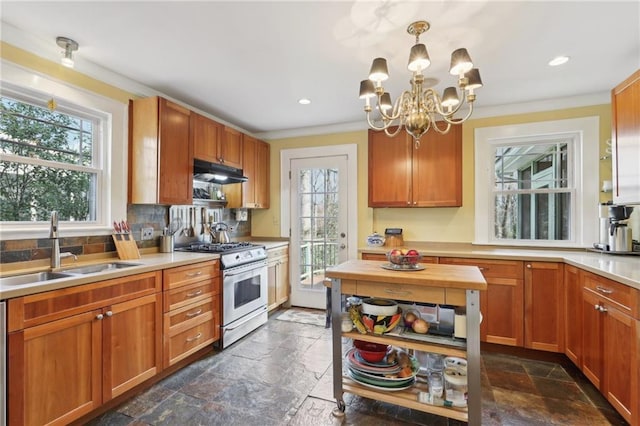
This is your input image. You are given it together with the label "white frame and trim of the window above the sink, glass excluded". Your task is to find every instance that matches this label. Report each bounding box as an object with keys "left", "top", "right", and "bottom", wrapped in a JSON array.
[{"left": 0, "top": 61, "right": 128, "bottom": 240}]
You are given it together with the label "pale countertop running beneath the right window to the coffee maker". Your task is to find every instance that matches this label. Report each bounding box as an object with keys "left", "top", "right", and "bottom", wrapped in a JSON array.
[{"left": 358, "top": 241, "right": 640, "bottom": 290}]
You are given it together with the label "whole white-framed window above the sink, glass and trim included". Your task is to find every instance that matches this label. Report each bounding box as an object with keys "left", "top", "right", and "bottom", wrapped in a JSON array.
[{"left": 0, "top": 62, "right": 127, "bottom": 240}]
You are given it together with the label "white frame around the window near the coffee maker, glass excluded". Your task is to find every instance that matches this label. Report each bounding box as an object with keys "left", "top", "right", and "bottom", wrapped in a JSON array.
[{"left": 474, "top": 117, "right": 599, "bottom": 248}]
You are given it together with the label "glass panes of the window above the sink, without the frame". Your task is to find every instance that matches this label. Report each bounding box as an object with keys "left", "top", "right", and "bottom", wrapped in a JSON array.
[{"left": 0, "top": 95, "right": 103, "bottom": 222}]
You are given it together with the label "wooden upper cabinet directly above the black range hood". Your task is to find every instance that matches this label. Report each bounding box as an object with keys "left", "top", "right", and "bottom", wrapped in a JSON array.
[{"left": 191, "top": 112, "right": 242, "bottom": 169}]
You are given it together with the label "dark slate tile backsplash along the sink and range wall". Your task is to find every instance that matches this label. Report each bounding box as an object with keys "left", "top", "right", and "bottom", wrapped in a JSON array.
[{"left": 0, "top": 204, "right": 251, "bottom": 263}]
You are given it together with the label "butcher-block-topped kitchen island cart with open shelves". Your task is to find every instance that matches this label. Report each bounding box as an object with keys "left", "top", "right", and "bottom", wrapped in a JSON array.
[{"left": 326, "top": 260, "right": 487, "bottom": 425}]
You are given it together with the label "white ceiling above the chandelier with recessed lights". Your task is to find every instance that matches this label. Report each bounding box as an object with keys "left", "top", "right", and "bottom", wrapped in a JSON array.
[{"left": 0, "top": 0, "right": 640, "bottom": 139}]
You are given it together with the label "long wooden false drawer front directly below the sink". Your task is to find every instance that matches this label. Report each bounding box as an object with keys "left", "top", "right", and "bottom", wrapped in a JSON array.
[{"left": 8, "top": 271, "right": 161, "bottom": 331}]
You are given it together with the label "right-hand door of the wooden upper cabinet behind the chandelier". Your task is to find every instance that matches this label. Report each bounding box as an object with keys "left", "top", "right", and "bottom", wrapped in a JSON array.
[{"left": 412, "top": 126, "right": 462, "bottom": 207}]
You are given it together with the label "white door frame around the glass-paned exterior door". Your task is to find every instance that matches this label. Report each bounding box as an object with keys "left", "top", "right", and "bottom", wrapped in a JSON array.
[{"left": 280, "top": 144, "right": 358, "bottom": 260}]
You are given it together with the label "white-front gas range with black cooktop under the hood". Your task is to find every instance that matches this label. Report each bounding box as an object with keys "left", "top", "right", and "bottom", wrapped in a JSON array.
[{"left": 176, "top": 242, "right": 268, "bottom": 348}]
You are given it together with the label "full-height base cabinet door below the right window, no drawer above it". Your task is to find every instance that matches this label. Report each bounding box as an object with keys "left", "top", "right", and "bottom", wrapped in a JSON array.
[{"left": 524, "top": 262, "right": 564, "bottom": 352}]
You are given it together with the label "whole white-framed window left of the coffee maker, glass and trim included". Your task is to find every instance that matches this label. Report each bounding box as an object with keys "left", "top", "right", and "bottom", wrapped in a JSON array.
[{"left": 475, "top": 117, "right": 598, "bottom": 247}]
